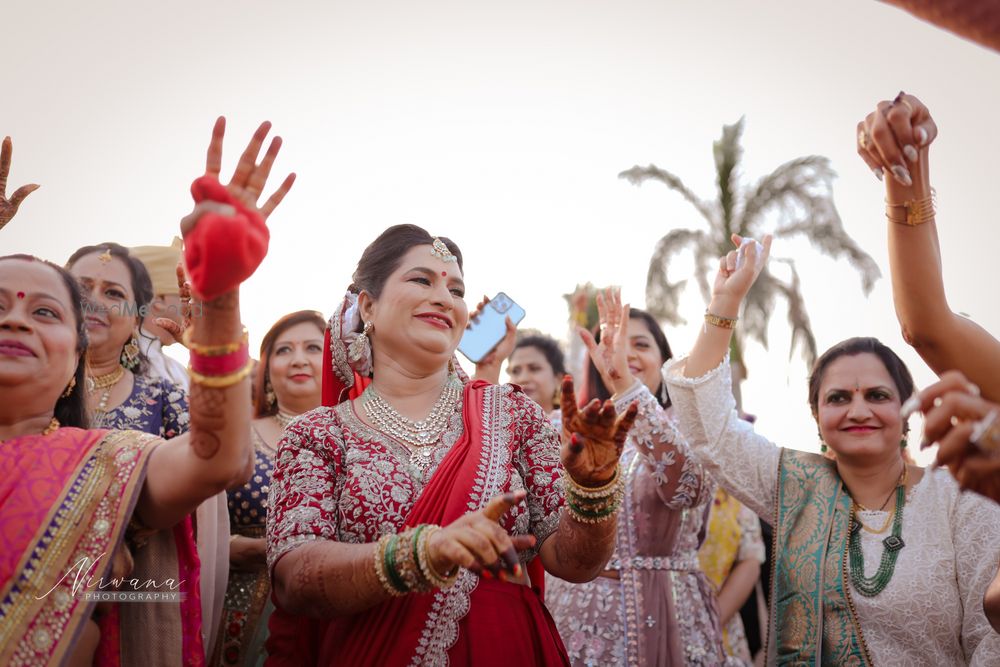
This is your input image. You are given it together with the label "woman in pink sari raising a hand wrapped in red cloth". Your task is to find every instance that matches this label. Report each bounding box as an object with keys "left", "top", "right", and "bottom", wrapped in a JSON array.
[{"left": 0, "top": 119, "right": 291, "bottom": 667}]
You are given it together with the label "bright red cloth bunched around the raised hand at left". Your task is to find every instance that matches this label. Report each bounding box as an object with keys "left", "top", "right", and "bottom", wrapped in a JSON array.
[{"left": 184, "top": 176, "right": 270, "bottom": 300}]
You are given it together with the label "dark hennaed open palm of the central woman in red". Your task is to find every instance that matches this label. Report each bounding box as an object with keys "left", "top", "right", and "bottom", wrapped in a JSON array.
[{"left": 560, "top": 375, "right": 639, "bottom": 488}]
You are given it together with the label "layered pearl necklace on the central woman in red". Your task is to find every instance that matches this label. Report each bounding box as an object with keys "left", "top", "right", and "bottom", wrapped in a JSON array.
[{"left": 361, "top": 376, "right": 462, "bottom": 472}]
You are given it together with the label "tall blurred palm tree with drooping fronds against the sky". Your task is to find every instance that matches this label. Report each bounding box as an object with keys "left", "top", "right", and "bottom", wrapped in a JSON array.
[{"left": 618, "top": 118, "right": 881, "bottom": 376}]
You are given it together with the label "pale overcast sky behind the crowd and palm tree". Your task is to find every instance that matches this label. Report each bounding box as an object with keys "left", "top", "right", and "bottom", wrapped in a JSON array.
[{"left": 0, "top": 0, "right": 1000, "bottom": 456}]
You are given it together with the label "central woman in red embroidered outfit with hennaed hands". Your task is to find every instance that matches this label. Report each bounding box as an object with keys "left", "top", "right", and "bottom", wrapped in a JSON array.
[{"left": 268, "top": 225, "right": 635, "bottom": 667}]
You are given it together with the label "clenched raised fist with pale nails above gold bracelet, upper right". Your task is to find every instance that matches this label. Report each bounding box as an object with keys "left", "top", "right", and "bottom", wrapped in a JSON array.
[{"left": 856, "top": 92, "right": 937, "bottom": 188}]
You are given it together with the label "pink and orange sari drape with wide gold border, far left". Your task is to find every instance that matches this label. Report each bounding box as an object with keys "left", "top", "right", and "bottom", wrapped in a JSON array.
[{"left": 0, "top": 428, "right": 159, "bottom": 665}]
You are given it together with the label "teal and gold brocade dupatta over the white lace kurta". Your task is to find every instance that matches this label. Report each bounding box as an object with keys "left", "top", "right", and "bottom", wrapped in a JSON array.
[{"left": 767, "top": 449, "right": 871, "bottom": 666}]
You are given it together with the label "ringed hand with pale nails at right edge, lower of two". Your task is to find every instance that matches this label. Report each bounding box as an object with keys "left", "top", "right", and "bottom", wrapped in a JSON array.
[{"left": 903, "top": 371, "right": 1000, "bottom": 503}]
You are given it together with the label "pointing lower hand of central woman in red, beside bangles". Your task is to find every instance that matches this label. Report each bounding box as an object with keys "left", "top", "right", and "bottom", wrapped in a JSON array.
[{"left": 427, "top": 489, "right": 535, "bottom": 579}]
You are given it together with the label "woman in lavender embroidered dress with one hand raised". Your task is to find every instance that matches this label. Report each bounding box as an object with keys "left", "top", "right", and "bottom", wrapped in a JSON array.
[{"left": 545, "top": 294, "right": 725, "bottom": 667}]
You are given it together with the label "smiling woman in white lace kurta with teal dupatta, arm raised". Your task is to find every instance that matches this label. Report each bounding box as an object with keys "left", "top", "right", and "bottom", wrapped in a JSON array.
[{"left": 664, "top": 237, "right": 1000, "bottom": 667}]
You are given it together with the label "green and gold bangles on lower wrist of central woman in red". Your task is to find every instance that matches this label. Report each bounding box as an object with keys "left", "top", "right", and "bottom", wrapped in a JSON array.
[{"left": 375, "top": 523, "right": 458, "bottom": 597}]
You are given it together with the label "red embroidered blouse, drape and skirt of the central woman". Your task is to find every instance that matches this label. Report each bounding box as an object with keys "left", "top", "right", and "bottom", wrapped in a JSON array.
[{"left": 268, "top": 382, "right": 567, "bottom": 666}]
